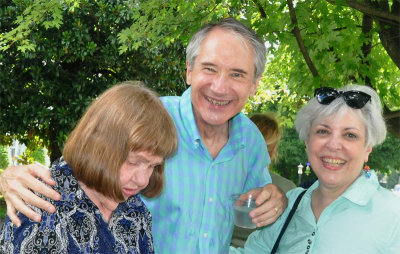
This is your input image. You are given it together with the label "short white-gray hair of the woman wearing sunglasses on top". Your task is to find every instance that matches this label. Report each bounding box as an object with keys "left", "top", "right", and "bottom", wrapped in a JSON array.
[{"left": 295, "top": 85, "right": 386, "bottom": 147}]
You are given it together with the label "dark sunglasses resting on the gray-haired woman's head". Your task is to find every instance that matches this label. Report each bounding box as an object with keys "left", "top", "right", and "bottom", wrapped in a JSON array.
[{"left": 314, "top": 87, "right": 371, "bottom": 109}]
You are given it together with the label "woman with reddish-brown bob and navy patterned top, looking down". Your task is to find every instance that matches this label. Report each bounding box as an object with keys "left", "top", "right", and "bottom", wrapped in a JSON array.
[{"left": 0, "top": 81, "right": 177, "bottom": 253}]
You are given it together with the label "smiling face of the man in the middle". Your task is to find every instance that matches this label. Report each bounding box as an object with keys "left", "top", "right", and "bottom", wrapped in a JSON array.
[{"left": 186, "top": 28, "right": 259, "bottom": 128}]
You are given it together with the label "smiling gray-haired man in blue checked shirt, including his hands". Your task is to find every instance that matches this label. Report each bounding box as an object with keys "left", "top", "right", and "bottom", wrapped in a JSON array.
[{"left": 0, "top": 18, "right": 287, "bottom": 253}]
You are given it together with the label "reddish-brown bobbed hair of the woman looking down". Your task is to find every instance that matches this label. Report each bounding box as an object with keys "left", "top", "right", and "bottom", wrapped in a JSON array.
[{"left": 63, "top": 81, "right": 177, "bottom": 201}]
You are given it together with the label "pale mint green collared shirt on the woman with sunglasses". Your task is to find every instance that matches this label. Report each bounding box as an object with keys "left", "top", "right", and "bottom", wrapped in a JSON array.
[{"left": 229, "top": 170, "right": 400, "bottom": 254}]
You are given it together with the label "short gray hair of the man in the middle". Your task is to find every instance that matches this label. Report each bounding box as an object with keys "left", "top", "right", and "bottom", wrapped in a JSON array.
[{"left": 186, "top": 18, "right": 267, "bottom": 80}]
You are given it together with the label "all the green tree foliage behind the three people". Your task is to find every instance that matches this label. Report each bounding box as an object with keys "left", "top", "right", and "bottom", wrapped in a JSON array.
[{"left": 0, "top": 0, "right": 400, "bottom": 161}]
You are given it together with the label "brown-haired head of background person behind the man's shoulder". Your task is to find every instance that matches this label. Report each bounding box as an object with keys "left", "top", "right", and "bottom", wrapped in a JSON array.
[{"left": 250, "top": 112, "right": 282, "bottom": 159}]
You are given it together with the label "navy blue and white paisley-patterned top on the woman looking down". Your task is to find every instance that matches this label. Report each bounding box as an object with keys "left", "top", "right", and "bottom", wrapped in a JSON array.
[{"left": 0, "top": 158, "right": 154, "bottom": 253}]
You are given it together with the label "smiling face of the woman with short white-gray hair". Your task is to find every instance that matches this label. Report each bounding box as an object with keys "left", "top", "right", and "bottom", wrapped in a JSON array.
[{"left": 306, "top": 108, "right": 372, "bottom": 192}]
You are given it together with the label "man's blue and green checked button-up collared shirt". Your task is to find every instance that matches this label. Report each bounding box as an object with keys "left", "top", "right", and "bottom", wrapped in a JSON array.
[{"left": 144, "top": 88, "right": 271, "bottom": 254}]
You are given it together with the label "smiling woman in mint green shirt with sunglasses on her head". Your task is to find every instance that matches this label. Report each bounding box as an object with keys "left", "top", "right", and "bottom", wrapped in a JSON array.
[{"left": 230, "top": 85, "right": 400, "bottom": 254}]
